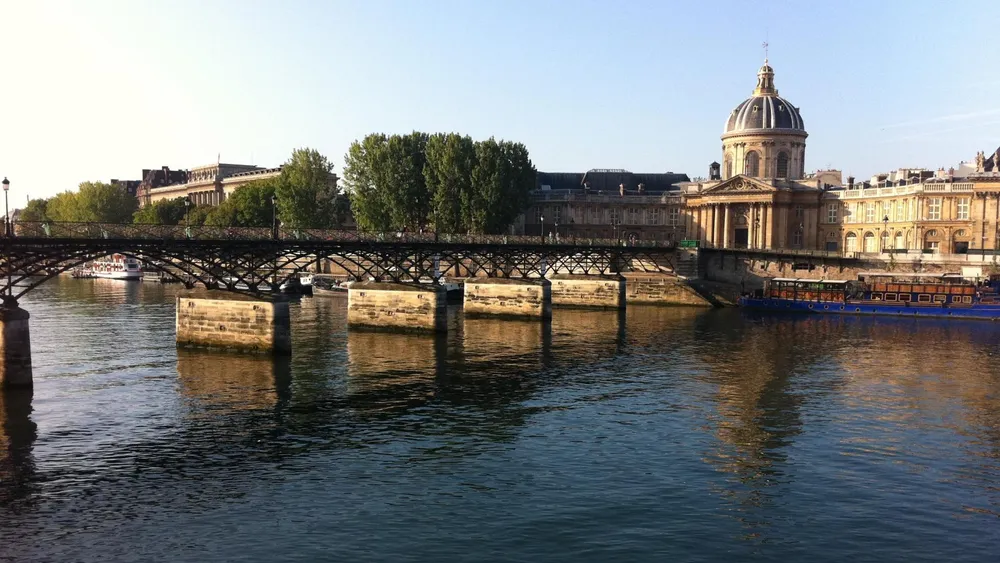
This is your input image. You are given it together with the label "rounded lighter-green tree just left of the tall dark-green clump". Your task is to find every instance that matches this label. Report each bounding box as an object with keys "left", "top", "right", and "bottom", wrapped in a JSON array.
[{"left": 275, "top": 149, "right": 339, "bottom": 228}]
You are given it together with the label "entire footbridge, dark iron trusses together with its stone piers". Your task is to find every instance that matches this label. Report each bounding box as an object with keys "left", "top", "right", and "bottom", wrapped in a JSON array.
[{"left": 0, "top": 222, "right": 676, "bottom": 386}]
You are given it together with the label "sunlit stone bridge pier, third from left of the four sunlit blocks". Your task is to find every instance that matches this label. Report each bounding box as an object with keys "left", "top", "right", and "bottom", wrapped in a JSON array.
[{"left": 464, "top": 278, "right": 552, "bottom": 319}]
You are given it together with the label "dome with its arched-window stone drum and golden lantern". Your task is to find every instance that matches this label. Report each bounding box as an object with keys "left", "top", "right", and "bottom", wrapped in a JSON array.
[{"left": 722, "top": 60, "right": 809, "bottom": 180}]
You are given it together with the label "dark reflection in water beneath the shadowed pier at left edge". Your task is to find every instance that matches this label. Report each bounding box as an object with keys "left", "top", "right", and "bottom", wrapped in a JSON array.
[{"left": 0, "top": 389, "right": 38, "bottom": 513}]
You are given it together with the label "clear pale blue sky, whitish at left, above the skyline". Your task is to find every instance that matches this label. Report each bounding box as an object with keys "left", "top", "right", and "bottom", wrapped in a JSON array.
[{"left": 0, "top": 0, "right": 1000, "bottom": 203}]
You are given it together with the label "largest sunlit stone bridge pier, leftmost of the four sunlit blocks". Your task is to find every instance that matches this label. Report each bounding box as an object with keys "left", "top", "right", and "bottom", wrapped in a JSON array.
[{"left": 177, "top": 293, "right": 292, "bottom": 355}]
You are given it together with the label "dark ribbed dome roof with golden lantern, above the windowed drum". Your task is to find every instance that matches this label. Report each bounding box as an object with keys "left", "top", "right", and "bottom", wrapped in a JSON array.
[{"left": 724, "top": 61, "right": 806, "bottom": 134}]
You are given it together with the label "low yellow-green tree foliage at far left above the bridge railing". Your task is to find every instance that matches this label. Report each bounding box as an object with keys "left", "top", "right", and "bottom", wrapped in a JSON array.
[{"left": 46, "top": 182, "right": 139, "bottom": 223}]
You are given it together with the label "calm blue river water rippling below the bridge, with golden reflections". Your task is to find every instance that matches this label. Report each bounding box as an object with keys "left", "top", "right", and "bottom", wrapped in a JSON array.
[{"left": 0, "top": 278, "right": 1000, "bottom": 562}]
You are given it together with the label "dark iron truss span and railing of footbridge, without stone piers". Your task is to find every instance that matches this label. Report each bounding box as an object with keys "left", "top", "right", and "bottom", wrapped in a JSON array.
[{"left": 0, "top": 222, "right": 674, "bottom": 305}]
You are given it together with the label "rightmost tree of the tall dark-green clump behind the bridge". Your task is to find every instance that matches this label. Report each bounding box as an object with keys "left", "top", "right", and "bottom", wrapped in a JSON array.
[{"left": 462, "top": 137, "right": 535, "bottom": 233}]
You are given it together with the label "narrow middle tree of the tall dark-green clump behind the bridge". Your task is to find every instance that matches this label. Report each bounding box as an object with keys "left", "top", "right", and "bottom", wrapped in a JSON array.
[{"left": 424, "top": 133, "right": 476, "bottom": 233}]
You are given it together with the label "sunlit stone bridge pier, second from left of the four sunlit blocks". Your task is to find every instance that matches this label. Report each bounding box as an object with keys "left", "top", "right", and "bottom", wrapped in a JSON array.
[{"left": 347, "top": 282, "right": 448, "bottom": 332}]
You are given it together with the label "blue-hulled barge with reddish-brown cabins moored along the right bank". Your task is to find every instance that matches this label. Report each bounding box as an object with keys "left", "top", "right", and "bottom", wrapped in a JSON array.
[{"left": 739, "top": 274, "right": 1000, "bottom": 321}]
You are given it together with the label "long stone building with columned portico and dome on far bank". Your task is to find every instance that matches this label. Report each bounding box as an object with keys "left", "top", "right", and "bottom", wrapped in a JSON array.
[{"left": 520, "top": 61, "right": 1000, "bottom": 254}]
